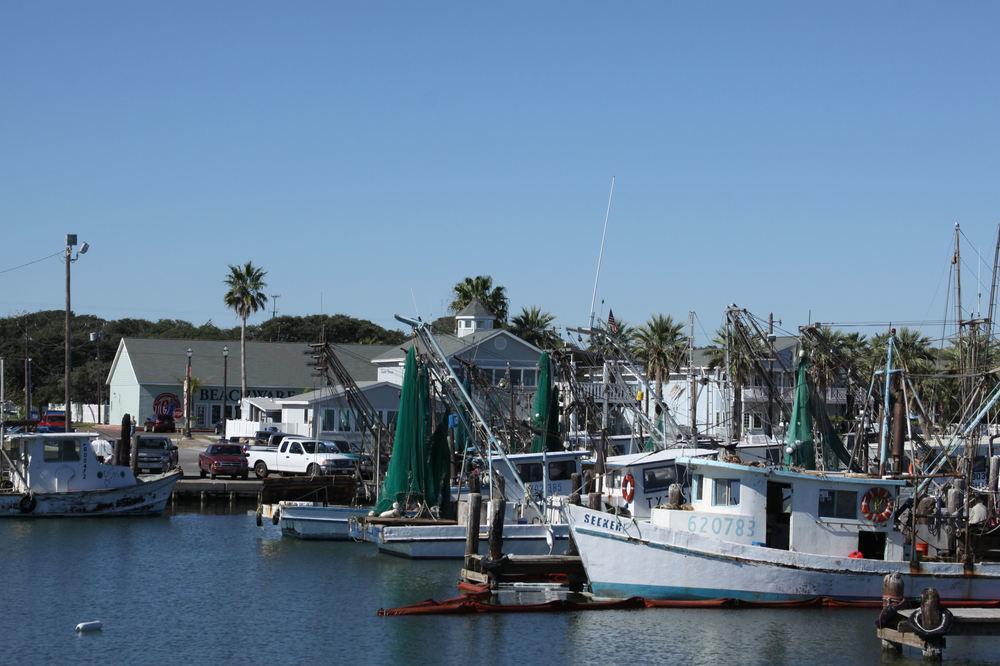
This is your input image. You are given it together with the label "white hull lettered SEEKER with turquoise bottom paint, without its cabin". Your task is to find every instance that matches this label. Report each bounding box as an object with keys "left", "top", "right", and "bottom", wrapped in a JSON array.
[{"left": 564, "top": 506, "right": 1000, "bottom": 602}]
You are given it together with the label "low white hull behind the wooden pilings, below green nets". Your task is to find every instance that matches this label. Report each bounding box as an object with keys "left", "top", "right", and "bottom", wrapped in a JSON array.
[{"left": 352, "top": 522, "right": 570, "bottom": 560}]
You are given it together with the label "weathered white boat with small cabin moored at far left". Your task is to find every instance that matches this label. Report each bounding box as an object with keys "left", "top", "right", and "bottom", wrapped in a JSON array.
[{"left": 0, "top": 433, "right": 181, "bottom": 518}]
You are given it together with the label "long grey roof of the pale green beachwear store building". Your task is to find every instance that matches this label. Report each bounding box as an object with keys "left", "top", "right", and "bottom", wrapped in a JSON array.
[{"left": 108, "top": 338, "right": 395, "bottom": 388}]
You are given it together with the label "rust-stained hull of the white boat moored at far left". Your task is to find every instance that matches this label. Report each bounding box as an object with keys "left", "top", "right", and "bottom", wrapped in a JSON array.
[{"left": 0, "top": 470, "right": 181, "bottom": 518}]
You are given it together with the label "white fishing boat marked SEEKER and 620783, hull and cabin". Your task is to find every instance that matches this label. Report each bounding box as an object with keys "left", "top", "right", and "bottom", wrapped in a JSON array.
[{"left": 564, "top": 458, "right": 1000, "bottom": 602}]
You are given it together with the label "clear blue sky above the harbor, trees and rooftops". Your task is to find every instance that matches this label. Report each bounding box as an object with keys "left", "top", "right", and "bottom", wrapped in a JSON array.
[{"left": 0, "top": 0, "right": 1000, "bottom": 342}]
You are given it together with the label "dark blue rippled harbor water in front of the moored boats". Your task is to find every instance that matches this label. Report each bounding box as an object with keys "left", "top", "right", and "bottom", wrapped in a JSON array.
[{"left": 0, "top": 512, "right": 1000, "bottom": 665}]
